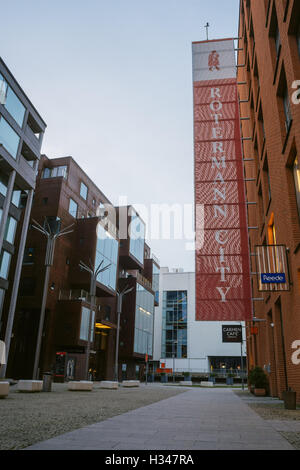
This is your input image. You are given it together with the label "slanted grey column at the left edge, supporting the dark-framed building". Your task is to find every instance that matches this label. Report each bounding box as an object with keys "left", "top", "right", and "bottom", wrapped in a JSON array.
[{"left": 0, "top": 189, "right": 34, "bottom": 378}]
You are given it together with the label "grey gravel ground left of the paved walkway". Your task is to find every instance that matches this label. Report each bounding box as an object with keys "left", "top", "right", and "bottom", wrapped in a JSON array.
[{"left": 0, "top": 384, "right": 184, "bottom": 450}]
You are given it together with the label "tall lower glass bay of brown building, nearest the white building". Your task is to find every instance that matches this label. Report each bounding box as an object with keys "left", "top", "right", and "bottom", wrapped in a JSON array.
[{"left": 134, "top": 283, "right": 154, "bottom": 356}]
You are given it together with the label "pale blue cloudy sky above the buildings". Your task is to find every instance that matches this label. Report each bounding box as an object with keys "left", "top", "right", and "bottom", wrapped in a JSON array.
[{"left": 0, "top": 0, "right": 239, "bottom": 271}]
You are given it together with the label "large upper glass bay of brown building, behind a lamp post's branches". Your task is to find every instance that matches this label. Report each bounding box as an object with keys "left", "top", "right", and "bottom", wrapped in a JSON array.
[{"left": 95, "top": 224, "right": 119, "bottom": 290}]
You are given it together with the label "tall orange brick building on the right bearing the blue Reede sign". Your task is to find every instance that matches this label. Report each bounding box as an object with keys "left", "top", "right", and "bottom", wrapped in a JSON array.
[{"left": 238, "top": 0, "right": 300, "bottom": 401}]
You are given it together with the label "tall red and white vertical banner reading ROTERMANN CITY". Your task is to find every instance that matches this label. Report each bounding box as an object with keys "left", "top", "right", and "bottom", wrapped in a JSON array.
[{"left": 193, "top": 39, "right": 252, "bottom": 321}]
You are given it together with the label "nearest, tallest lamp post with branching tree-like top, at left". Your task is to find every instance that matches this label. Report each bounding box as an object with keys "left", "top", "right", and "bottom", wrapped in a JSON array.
[{"left": 32, "top": 219, "right": 74, "bottom": 380}]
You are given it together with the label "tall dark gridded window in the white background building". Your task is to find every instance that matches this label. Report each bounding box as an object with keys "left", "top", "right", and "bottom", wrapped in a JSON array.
[{"left": 162, "top": 291, "right": 187, "bottom": 359}]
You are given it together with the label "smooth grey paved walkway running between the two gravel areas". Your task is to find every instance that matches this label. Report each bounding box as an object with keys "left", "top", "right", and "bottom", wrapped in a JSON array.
[{"left": 27, "top": 388, "right": 294, "bottom": 450}]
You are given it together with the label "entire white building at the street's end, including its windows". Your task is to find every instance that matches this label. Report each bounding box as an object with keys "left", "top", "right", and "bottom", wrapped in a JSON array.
[{"left": 153, "top": 268, "right": 246, "bottom": 374}]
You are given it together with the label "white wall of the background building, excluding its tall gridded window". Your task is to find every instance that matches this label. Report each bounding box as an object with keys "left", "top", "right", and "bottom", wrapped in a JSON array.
[{"left": 153, "top": 268, "right": 246, "bottom": 372}]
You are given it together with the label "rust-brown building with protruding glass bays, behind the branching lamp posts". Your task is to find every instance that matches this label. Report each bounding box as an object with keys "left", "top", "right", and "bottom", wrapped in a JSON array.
[{"left": 2, "top": 155, "right": 159, "bottom": 381}]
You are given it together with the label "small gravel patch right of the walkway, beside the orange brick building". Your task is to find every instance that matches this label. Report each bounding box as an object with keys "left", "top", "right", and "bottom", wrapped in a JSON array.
[{"left": 235, "top": 391, "right": 300, "bottom": 450}]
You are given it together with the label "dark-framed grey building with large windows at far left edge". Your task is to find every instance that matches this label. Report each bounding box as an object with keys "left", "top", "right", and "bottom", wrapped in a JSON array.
[{"left": 0, "top": 58, "right": 46, "bottom": 368}]
